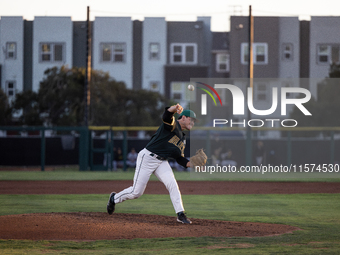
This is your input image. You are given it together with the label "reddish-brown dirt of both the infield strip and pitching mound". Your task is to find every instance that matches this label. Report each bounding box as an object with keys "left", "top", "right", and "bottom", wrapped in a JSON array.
[{"left": 0, "top": 181, "right": 340, "bottom": 240}]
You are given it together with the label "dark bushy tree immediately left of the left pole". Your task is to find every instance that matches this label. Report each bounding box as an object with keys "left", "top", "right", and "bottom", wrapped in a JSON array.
[{"left": 14, "top": 67, "right": 84, "bottom": 126}]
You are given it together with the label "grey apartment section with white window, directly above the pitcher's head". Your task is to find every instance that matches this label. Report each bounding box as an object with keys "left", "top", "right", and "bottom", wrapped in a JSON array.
[{"left": 165, "top": 19, "right": 212, "bottom": 105}]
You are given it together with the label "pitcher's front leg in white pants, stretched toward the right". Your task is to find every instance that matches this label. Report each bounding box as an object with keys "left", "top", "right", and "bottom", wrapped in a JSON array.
[{"left": 154, "top": 161, "right": 184, "bottom": 213}]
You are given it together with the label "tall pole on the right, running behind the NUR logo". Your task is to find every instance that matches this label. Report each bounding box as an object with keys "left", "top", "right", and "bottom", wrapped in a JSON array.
[{"left": 246, "top": 5, "right": 254, "bottom": 166}]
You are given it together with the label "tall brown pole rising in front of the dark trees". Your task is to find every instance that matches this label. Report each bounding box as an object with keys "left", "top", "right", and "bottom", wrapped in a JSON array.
[{"left": 84, "top": 6, "right": 92, "bottom": 126}]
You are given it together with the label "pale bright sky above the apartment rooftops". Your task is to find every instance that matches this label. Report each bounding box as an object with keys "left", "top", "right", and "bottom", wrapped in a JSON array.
[{"left": 0, "top": 0, "right": 340, "bottom": 32}]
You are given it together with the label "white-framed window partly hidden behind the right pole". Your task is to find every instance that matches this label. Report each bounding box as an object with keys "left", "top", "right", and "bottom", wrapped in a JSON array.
[{"left": 241, "top": 43, "right": 268, "bottom": 65}]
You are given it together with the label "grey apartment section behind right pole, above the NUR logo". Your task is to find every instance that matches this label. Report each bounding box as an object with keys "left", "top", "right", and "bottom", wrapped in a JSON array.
[{"left": 229, "top": 16, "right": 300, "bottom": 78}]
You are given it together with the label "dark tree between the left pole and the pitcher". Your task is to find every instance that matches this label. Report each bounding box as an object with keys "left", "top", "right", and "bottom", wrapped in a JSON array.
[{"left": 91, "top": 71, "right": 167, "bottom": 126}]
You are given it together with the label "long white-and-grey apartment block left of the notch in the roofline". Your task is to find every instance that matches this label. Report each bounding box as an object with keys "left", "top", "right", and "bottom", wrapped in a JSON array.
[{"left": 0, "top": 17, "right": 220, "bottom": 108}]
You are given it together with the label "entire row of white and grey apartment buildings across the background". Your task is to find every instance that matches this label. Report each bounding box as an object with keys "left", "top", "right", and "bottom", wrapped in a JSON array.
[{"left": 0, "top": 16, "right": 340, "bottom": 113}]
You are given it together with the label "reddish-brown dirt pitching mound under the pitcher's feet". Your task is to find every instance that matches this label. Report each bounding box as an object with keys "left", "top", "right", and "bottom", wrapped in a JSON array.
[{"left": 0, "top": 213, "right": 298, "bottom": 240}]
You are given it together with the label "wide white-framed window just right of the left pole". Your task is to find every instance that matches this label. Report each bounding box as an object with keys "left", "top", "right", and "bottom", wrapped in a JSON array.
[{"left": 100, "top": 42, "right": 126, "bottom": 63}]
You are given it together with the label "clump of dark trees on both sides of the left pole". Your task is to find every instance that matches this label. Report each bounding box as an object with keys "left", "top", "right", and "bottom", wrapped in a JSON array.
[{"left": 15, "top": 67, "right": 167, "bottom": 126}]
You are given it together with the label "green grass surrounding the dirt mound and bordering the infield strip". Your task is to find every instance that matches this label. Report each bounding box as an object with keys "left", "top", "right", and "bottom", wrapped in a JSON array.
[{"left": 0, "top": 168, "right": 340, "bottom": 254}]
